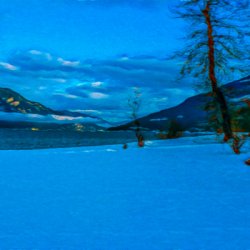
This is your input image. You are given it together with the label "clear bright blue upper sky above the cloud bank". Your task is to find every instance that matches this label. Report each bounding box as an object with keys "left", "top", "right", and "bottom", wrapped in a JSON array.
[{"left": 0, "top": 0, "right": 182, "bottom": 58}]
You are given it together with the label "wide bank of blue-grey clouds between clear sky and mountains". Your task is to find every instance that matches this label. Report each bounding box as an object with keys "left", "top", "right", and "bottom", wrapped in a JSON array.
[{"left": 0, "top": 50, "right": 194, "bottom": 120}]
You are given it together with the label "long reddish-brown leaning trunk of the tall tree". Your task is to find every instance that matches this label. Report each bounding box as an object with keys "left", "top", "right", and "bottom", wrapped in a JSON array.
[{"left": 202, "top": 0, "right": 233, "bottom": 141}]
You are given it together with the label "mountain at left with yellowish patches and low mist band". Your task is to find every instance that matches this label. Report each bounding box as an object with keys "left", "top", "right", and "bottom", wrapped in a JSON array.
[{"left": 0, "top": 88, "right": 108, "bottom": 128}]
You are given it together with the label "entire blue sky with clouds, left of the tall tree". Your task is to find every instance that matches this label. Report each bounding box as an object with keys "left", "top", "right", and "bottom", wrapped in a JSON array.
[{"left": 0, "top": 0, "right": 246, "bottom": 122}]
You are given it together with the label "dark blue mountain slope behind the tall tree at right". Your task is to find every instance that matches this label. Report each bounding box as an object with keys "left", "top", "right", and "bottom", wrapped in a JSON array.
[{"left": 110, "top": 76, "right": 250, "bottom": 131}]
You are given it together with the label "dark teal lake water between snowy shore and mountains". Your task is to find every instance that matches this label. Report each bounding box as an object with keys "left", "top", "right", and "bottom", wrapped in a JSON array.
[{"left": 0, "top": 129, "right": 156, "bottom": 150}]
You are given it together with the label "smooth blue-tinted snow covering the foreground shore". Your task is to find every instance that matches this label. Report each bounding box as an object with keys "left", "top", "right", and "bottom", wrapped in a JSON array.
[{"left": 0, "top": 137, "right": 250, "bottom": 250}]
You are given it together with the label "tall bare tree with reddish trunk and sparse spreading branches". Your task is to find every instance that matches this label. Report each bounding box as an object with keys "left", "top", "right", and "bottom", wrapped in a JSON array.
[{"left": 173, "top": 0, "right": 250, "bottom": 150}]
